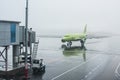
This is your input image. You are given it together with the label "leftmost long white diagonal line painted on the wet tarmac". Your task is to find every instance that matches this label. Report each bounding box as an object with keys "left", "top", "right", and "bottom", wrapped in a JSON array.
[{"left": 51, "top": 55, "right": 99, "bottom": 80}]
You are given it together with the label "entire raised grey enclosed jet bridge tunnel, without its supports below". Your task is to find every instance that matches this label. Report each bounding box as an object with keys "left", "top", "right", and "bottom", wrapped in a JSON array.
[{"left": 0, "top": 20, "right": 36, "bottom": 47}]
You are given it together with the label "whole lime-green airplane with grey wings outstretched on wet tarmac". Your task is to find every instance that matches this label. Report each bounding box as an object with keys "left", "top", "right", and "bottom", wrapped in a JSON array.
[{"left": 37, "top": 24, "right": 110, "bottom": 49}]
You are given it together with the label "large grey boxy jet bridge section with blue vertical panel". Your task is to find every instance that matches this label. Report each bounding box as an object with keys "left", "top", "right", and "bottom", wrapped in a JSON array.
[{"left": 0, "top": 20, "right": 20, "bottom": 46}]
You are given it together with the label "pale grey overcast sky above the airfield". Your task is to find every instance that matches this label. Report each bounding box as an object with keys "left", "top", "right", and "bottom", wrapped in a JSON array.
[{"left": 0, "top": 0, "right": 120, "bottom": 34}]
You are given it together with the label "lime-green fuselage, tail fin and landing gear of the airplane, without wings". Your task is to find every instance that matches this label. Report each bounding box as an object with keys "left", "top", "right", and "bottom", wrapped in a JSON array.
[{"left": 61, "top": 24, "right": 87, "bottom": 48}]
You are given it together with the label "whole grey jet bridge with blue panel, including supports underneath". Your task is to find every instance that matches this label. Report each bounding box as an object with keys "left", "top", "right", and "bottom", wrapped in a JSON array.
[{"left": 0, "top": 20, "right": 36, "bottom": 79}]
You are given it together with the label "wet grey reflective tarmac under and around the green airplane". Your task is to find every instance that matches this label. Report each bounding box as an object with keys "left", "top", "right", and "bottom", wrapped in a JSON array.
[{"left": 31, "top": 36, "right": 120, "bottom": 80}]
